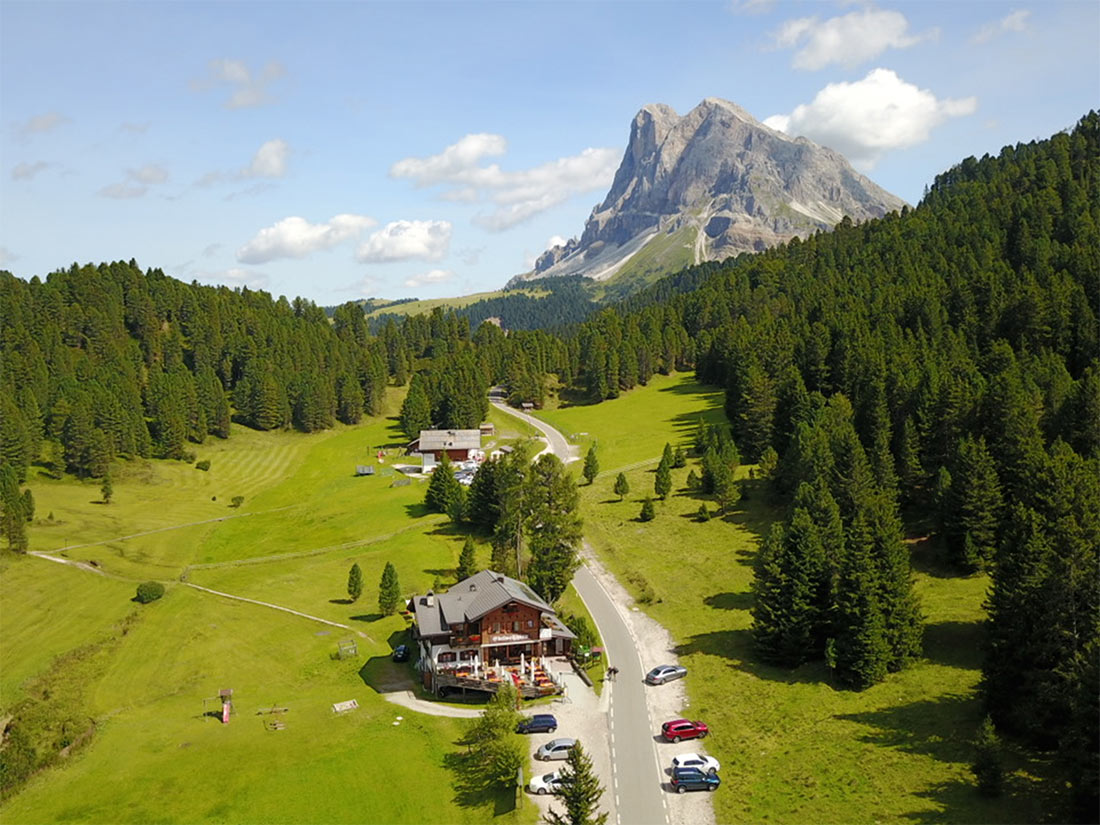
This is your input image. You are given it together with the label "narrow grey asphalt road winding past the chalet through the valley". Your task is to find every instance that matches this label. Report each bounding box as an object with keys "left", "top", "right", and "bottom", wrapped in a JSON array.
[{"left": 494, "top": 402, "right": 669, "bottom": 825}]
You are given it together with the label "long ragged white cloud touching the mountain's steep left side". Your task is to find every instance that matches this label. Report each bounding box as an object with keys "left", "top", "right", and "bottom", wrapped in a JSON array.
[{"left": 389, "top": 133, "right": 622, "bottom": 231}]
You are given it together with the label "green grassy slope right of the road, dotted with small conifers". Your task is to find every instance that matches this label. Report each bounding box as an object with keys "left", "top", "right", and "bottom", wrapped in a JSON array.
[{"left": 539, "top": 376, "right": 1047, "bottom": 823}]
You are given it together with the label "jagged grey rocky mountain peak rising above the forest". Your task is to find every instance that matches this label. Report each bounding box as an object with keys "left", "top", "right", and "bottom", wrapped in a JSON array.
[{"left": 528, "top": 98, "right": 904, "bottom": 279}]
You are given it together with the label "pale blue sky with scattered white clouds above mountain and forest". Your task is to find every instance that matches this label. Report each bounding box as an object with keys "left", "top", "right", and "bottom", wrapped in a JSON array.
[{"left": 0, "top": 0, "right": 1100, "bottom": 306}]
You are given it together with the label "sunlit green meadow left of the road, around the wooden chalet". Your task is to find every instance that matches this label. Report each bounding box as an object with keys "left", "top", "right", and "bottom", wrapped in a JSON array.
[{"left": 0, "top": 393, "right": 537, "bottom": 824}]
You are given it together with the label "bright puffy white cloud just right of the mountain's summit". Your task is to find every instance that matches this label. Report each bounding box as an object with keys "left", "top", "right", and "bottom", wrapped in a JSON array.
[{"left": 765, "top": 68, "right": 978, "bottom": 171}]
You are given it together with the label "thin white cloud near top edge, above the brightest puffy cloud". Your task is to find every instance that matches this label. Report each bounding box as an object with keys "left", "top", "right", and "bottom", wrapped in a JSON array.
[{"left": 774, "top": 7, "right": 938, "bottom": 70}]
